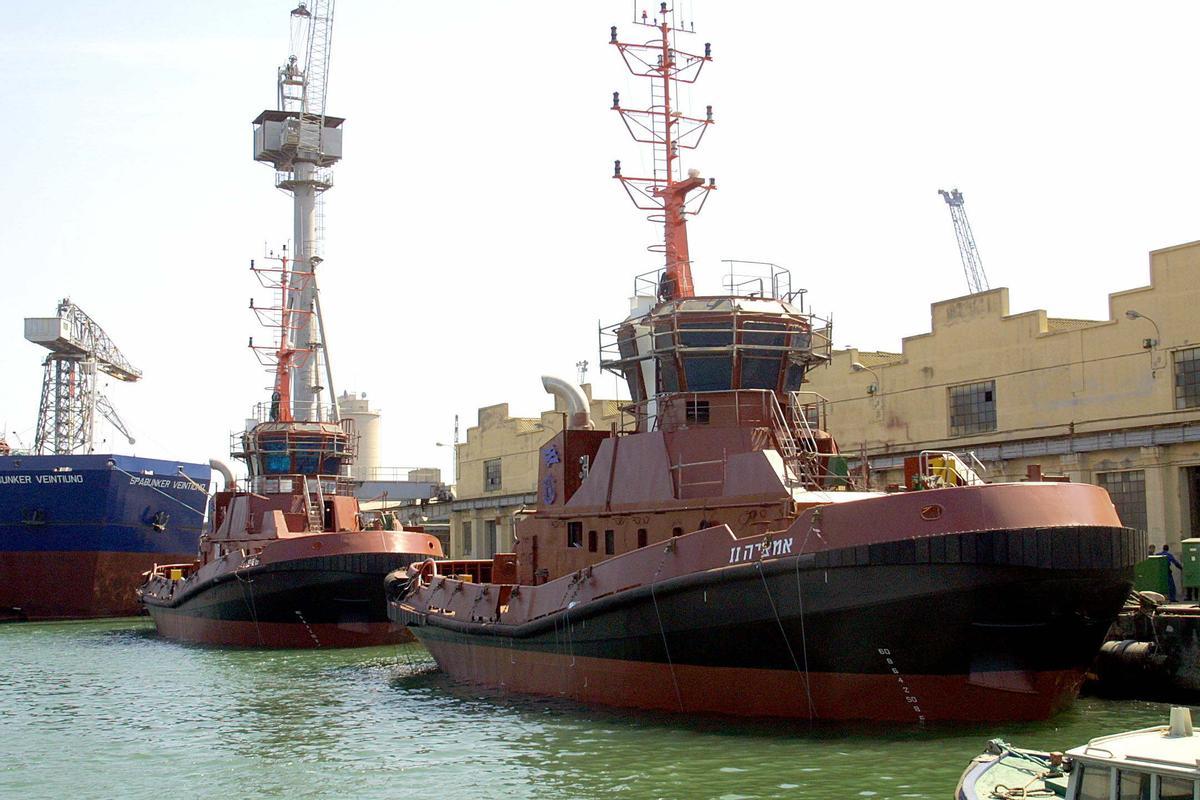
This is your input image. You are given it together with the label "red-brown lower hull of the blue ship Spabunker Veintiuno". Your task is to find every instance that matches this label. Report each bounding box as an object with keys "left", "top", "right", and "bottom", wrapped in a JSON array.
[{"left": 0, "top": 551, "right": 192, "bottom": 621}]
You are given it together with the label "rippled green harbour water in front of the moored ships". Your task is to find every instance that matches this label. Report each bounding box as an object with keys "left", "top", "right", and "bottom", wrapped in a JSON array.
[{"left": 0, "top": 619, "right": 1168, "bottom": 800}]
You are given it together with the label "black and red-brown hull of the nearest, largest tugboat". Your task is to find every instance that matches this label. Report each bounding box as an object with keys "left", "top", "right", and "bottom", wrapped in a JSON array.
[{"left": 389, "top": 485, "right": 1145, "bottom": 722}]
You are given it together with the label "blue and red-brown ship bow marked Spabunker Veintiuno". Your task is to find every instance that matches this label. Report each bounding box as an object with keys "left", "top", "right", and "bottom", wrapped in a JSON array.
[{"left": 0, "top": 455, "right": 211, "bottom": 619}]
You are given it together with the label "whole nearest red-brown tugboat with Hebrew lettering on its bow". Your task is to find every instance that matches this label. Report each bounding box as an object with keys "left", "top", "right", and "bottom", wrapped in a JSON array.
[{"left": 389, "top": 4, "right": 1145, "bottom": 723}]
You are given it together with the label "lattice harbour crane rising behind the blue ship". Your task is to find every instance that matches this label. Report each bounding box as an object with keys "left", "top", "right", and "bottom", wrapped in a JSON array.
[{"left": 25, "top": 299, "right": 142, "bottom": 456}]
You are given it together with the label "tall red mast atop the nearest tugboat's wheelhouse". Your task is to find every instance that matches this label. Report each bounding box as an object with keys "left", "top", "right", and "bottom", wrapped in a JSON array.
[{"left": 610, "top": 2, "right": 716, "bottom": 300}]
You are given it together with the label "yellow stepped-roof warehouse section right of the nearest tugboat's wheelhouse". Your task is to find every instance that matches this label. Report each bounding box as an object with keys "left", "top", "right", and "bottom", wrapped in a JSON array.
[{"left": 804, "top": 237, "right": 1200, "bottom": 549}]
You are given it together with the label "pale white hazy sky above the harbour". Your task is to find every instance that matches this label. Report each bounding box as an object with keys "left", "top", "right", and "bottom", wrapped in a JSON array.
[{"left": 0, "top": 0, "right": 1200, "bottom": 482}]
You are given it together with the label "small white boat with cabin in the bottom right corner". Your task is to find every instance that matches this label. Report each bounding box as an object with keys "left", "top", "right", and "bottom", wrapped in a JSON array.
[{"left": 954, "top": 708, "right": 1200, "bottom": 800}]
